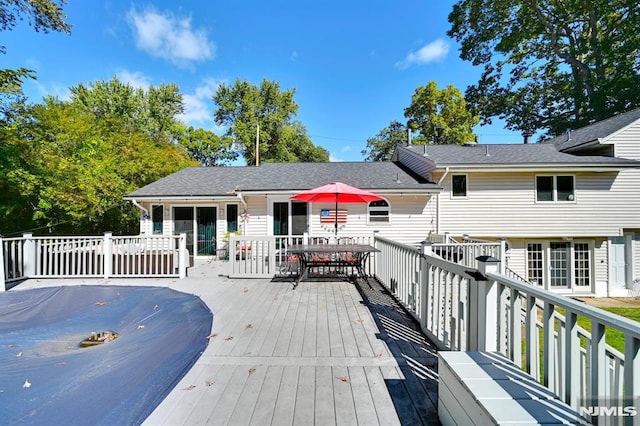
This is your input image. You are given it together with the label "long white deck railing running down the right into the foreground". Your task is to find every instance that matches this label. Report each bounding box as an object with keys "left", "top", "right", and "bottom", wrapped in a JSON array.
[{"left": 375, "top": 237, "right": 640, "bottom": 422}]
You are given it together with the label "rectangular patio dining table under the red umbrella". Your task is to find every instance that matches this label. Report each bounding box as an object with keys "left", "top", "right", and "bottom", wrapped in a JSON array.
[{"left": 287, "top": 244, "right": 380, "bottom": 285}]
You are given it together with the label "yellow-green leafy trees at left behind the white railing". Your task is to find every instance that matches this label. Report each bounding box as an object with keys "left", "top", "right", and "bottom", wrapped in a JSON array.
[{"left": 0, "top": 98, "right": 193, "bottom": 234}]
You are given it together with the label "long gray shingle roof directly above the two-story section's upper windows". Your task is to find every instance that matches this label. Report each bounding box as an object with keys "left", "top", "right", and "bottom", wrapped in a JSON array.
[{"left": 405, "top": 144, "right": 640, "bottom": 167}]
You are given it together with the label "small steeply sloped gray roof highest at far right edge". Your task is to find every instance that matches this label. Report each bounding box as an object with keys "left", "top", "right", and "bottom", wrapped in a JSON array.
[{"left": 544, "top": 108, "right": 640, "bottom": 151}]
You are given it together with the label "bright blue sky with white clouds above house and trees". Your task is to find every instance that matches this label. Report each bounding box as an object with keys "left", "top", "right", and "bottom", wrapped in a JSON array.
[{"left": 0, "top": 0, "right": 522, "bottom": 161}]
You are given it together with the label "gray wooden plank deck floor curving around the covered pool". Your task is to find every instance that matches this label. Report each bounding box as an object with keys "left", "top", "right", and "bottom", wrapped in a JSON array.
[{"left": 13, "top": 262, "right": 438, "bottom": 425}]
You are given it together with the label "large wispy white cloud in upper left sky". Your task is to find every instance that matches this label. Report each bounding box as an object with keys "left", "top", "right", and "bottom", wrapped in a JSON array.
[{"left": 129, "top": 8, "right": 215, "bottom": 67}]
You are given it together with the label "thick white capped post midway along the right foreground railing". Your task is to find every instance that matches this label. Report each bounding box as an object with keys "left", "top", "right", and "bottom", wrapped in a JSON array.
[{"left": 467, "top": 256, "right": 500, "bottom": 352}]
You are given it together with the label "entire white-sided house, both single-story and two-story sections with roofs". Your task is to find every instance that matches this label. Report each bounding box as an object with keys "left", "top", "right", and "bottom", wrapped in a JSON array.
[{"left": 125, "top": 109, "right": 640, "bottom": 296}]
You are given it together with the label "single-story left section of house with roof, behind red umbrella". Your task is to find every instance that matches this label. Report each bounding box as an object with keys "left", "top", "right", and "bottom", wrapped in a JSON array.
[{"left": 125, "top": 162, "right": 441, "bottom": 257}]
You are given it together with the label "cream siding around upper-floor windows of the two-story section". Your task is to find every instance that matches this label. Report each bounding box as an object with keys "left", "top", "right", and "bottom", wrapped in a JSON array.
[{"left": 440, "top": 172, "right": 640, "bottom": 238}]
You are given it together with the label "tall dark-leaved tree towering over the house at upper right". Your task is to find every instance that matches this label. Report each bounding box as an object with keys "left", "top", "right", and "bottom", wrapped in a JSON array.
[{"left": 448, "top": 0, "right": 640, "bottom": 135}]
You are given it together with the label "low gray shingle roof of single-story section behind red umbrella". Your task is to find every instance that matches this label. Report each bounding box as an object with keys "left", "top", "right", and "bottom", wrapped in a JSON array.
[{"left": 127, "top": 162, "right": 438, "bottom": 198}]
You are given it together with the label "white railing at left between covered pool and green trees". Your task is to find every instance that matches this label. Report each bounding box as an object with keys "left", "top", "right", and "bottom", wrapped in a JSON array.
[{"left": 0, "top": 233, "right": 188, "bottom": 290}]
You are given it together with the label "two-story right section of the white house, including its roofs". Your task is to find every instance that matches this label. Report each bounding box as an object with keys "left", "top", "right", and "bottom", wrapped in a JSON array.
[{"left": 394, "top": 110, "right": 640, "bottom": 296}]
